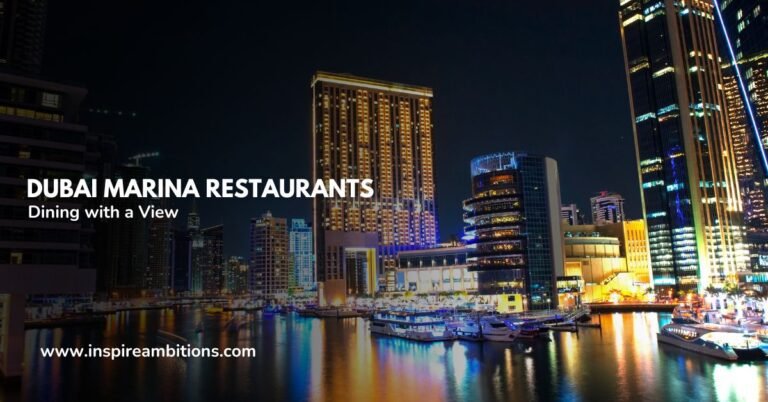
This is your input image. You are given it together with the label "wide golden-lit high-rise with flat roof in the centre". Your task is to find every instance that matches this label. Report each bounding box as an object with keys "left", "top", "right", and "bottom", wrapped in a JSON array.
[{"left": 312, "top": 72, "right": 438, "bottom": 299}]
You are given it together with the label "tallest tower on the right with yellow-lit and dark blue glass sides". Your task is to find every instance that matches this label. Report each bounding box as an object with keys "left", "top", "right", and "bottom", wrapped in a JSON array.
[{"left": 619, "top": 0, "right": 747, "bottom": 291}]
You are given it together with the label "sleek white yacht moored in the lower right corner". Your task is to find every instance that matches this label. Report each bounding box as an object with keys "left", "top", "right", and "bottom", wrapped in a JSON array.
[{"left": 657, "top": 318, "right": 768, "bottom": 361}]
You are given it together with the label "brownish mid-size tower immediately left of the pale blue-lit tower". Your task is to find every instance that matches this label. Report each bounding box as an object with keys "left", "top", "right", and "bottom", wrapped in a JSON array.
[{"left": 248, "top": 211, "right": 293, "bottom": 300}]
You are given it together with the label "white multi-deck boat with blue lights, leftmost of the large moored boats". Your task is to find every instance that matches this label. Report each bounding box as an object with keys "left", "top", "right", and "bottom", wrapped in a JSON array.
[{"left": 369, "top": 312, "right": 457, "bottom": 342}]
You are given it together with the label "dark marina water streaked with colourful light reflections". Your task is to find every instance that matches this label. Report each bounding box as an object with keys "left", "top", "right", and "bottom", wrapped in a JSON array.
[{"left": 0, "top": 309, "right": 768, "bottom": 402}]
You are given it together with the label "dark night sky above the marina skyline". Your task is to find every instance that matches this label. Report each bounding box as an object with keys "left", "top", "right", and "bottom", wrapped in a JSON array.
[{"left": 43, "top": 0, "right": 640, "bottom": 256}]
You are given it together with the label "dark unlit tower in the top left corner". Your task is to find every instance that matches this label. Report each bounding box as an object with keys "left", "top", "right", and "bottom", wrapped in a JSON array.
[{"left": 0, "top": 0, "right": 48, "bottom": 74}]
